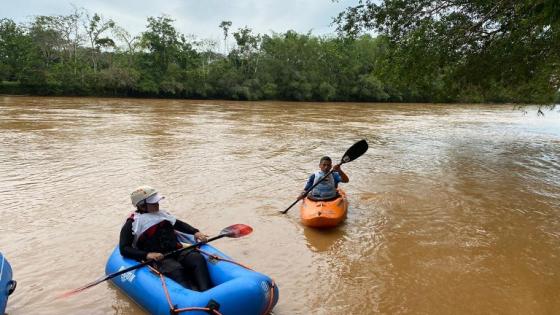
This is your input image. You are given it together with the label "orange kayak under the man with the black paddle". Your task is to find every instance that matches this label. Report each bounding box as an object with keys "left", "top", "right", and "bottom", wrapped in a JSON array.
[{"left": 300, "top": 188, "right": 348, "bottom": 228}]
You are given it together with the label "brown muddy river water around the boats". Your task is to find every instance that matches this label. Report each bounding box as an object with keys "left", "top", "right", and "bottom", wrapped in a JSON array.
[{"left": 0, "top": 96, "right": 560, "bottom": 315}]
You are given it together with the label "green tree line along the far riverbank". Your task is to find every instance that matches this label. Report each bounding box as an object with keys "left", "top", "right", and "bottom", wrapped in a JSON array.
[{"left": 0, "top": 1, "right": 560, "bottom": 104}]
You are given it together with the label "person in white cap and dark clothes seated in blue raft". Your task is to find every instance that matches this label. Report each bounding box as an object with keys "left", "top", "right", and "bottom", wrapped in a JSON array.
[{"left": 119, "top": 186, "right": 212, "bottom": 291}]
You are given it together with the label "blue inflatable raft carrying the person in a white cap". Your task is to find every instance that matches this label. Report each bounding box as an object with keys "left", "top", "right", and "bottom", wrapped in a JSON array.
[{"left": 105, "top": 238, "right": 278, "bottom": 315}]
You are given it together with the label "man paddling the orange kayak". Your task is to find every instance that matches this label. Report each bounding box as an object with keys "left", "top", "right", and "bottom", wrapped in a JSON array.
[{"left": 298, "top": 156, "right": 350, "bottom": 200}]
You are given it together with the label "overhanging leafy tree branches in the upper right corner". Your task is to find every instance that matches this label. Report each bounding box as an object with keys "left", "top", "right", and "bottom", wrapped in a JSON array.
[{"left": 336, "top": 0, "right": 560, "bottom": 102}]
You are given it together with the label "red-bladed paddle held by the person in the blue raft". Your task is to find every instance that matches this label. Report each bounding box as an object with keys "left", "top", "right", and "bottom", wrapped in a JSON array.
[{"left": 60, "top": 224, "right": 253, "bottom": 297}]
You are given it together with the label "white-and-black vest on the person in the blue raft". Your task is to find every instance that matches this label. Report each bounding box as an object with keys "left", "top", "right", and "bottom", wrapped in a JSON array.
[{"left": 131, "top": 210, "right": 181, "bottom": 253}]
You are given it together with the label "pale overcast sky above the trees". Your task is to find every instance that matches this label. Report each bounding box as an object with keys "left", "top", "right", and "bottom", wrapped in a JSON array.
[{"left": 0, "top": 0, "right": 358, "bottom": 42}]
